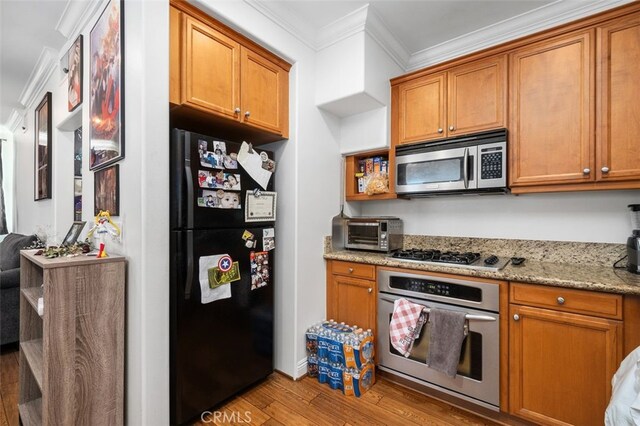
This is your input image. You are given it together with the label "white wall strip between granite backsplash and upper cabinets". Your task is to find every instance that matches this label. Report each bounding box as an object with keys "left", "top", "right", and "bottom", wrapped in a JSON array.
[{"left": 362, "top": 191, "right": 640, "bottom": 243}]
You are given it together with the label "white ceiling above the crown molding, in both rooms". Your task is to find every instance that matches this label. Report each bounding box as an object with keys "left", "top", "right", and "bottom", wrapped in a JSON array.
[{"left": 0, "top": 0, "right": 627, "bottom": 125}]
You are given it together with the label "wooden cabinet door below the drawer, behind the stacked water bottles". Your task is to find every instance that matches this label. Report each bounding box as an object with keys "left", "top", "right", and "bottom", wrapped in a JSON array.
[{"left": 327, "top": 275, "right": 376, "bottom": 335}]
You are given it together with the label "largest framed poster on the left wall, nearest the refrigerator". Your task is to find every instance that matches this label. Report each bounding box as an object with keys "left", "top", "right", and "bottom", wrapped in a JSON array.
[{"left": 89, "top": 0, "right": 124, "bottom": 170}]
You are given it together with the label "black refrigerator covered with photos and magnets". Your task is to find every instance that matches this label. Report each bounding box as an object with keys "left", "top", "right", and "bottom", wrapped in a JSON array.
[{"left": 170, "top": 129, "right": 275, "bottom": 424}]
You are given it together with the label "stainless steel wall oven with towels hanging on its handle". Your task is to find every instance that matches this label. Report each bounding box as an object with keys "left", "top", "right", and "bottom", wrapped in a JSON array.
[{"left": 377, "top": 268, "right": 500, "bottom": 410}]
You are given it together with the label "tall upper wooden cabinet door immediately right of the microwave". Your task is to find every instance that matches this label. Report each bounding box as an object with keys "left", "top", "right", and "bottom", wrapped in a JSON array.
[{"left": 509, "top": 31, "right": 595, "bottom": 186}]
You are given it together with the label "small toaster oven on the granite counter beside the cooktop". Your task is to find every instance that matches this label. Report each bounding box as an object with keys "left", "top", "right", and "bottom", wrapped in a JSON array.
[{"left": 344, "top": 217, "right": 403, "bottom": 253}]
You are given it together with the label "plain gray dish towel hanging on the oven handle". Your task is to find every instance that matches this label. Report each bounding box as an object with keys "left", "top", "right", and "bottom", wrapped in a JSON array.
[{"left": 427, "top": 308, "right": 465, "bottom": 377}]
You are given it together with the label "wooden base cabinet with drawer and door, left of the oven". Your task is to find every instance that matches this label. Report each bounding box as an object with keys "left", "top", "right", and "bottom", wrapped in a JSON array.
[{"left": 327, "top": 260, "right": 377, "bottom": 336}]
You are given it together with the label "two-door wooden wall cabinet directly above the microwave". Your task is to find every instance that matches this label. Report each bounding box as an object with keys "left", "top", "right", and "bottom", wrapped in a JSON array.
[{"left": 392, "top": 55, "right": 507, "bottom": 144}]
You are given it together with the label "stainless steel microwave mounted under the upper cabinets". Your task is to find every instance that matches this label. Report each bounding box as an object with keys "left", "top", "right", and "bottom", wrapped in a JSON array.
[{"left": 396, "top": 129, "right": 508, "bottom": 197}]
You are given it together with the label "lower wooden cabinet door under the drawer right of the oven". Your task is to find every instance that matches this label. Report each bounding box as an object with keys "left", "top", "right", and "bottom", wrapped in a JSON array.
[{"left": 509, "top": 305, "right": 622, "bottom": 426}]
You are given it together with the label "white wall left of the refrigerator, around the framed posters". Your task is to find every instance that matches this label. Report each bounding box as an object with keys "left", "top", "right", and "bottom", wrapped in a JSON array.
[{"left": 15, "top": 1, "right": 169, "bottom": 425}]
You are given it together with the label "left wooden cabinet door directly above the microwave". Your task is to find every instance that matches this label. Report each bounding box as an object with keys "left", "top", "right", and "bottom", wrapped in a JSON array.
[{"left": 398, "top": 74, "right": 446, "bottom": 144}]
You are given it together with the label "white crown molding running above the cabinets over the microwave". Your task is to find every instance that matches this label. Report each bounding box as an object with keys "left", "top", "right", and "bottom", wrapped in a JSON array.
[{"left": 406, "top": 0, "right": 634, "bottom": 71}]
